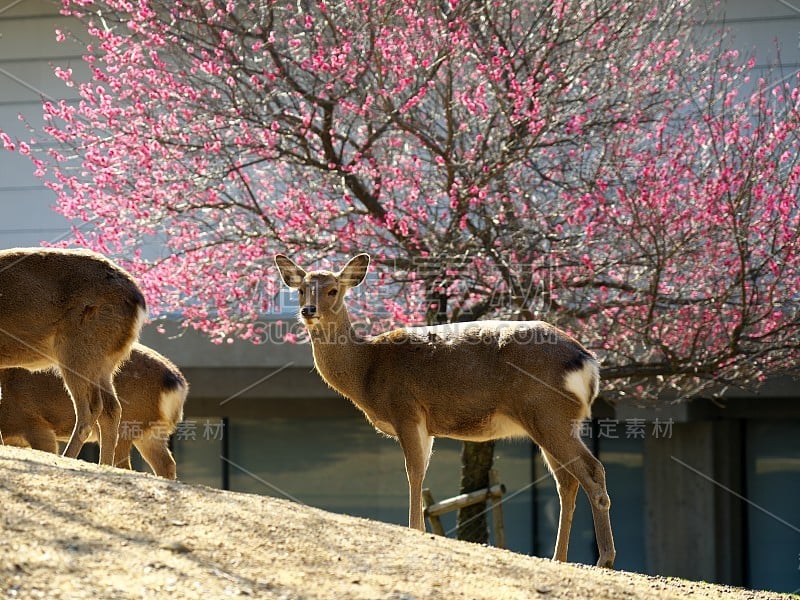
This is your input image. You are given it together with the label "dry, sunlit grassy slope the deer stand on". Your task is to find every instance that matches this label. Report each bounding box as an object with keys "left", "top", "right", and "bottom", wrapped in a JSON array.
[{"left": 0, "top": 447, "right": 779, "bottom": 600}]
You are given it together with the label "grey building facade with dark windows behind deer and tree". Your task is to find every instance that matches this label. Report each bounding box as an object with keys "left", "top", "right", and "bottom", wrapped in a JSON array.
[{"left": 0, "top": 0, "right": 800, "bottom": 592}]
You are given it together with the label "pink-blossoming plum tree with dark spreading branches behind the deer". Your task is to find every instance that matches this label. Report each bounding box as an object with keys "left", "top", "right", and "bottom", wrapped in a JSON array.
[{"left": 4, "top": 0, "right": 800, "bottom": 544}]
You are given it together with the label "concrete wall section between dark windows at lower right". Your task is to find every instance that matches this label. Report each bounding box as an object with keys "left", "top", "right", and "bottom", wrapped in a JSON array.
[{"left": 644, "top": 420, "right": 745, "bottom": 585}]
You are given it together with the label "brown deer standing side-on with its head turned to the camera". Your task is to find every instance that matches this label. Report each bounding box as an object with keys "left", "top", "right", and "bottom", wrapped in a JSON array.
[{"left": 275, "top": 254, "right": 616, "bottom": 568}]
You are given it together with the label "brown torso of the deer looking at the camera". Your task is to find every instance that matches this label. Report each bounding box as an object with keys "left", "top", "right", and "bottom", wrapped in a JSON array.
[{"left": 314, "top": 321, "right": 597, "bottom": 439}]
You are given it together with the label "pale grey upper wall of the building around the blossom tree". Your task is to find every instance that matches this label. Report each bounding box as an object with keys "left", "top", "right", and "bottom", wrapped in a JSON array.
[{"left": 0, "top": 0, "right": 800, "bottom": 376}]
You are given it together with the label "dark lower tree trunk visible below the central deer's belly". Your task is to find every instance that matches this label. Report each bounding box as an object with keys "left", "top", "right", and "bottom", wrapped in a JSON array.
[{"left": 456, "top": 441, "right": 494, "bottom": 544}]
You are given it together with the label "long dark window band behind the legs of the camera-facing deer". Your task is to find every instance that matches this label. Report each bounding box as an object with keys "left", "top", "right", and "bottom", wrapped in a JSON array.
[{"left": 174, "top": 417, "right": 645, "bottom": 571}]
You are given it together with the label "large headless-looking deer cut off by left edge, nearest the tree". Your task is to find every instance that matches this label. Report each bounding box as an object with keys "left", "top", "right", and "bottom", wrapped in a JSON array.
[{"left": 0, "top": 248, "right": 146, "bottom": 465}]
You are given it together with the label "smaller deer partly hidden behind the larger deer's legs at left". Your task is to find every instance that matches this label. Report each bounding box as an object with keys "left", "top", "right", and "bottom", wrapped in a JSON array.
[{"left": 0, "top": 344, "right": 189, "bottom": 479}]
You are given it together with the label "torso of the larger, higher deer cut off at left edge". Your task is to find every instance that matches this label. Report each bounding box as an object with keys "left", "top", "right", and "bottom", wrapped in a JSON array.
[{"left": 0, "top": 248, "right": 145, "bottom": 368}]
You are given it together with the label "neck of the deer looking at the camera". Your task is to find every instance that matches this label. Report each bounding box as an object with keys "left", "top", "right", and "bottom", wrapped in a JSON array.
[{"left": 308, "top": 310, "right": 368, "bottom": 400}]
